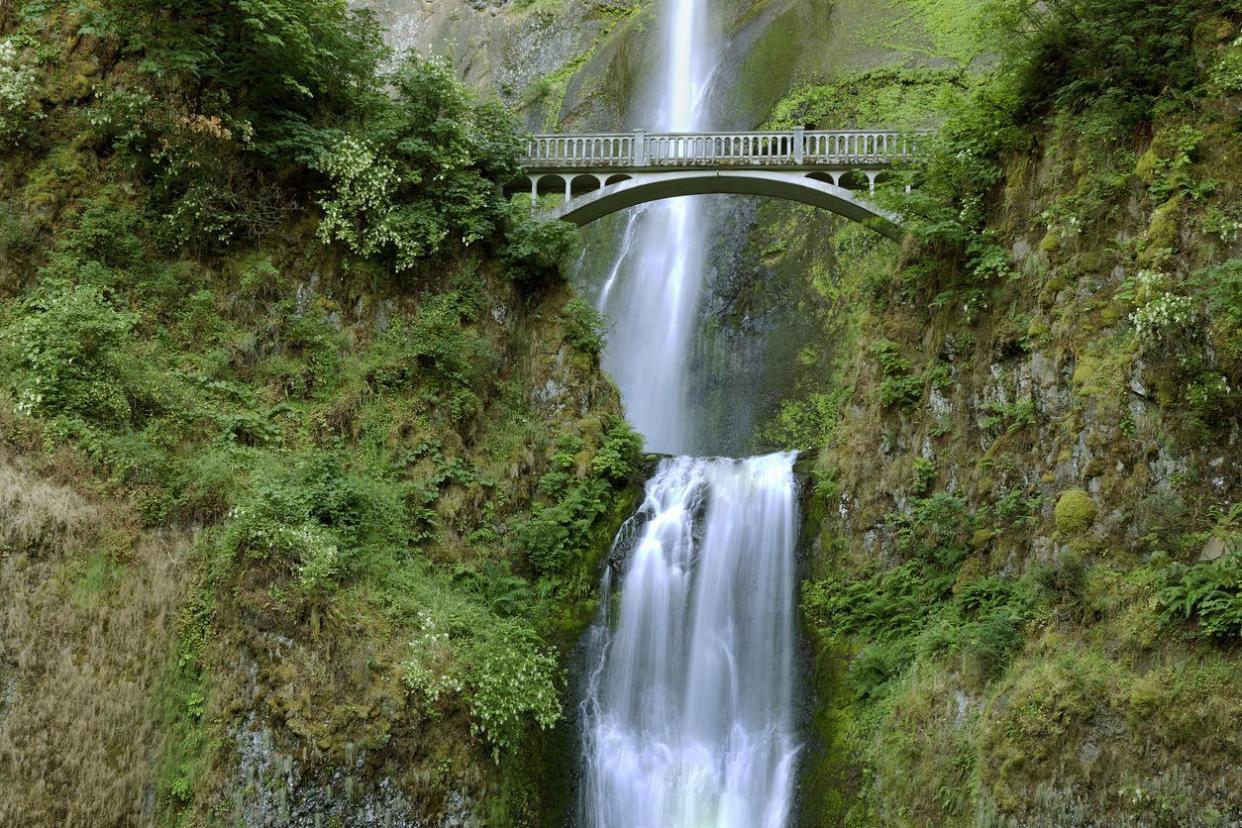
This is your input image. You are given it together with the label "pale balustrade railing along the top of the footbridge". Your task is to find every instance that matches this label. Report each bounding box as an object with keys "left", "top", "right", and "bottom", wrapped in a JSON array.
[{"left": 523, "top": 128, "right": 927, "bottom": 171}]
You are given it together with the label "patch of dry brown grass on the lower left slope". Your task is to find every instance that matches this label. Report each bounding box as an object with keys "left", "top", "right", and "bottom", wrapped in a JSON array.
[{"left": 0, "top": 462, "right": 190, "bottom": 827}]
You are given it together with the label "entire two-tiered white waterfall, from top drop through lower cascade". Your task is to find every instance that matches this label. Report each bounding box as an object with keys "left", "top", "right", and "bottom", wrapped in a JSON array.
[{"left": 580, "top": 0, "right": 797, "bottom": 828}]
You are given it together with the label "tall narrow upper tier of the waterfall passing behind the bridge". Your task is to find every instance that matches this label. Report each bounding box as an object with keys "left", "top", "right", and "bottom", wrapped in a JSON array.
[{"left": 600, "top": 0, "right": 719, "bottom": 453}]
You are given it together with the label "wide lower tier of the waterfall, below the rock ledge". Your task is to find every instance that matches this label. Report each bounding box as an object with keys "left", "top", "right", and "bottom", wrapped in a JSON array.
[{"left": 581, "top": 454, "right": 797, "bottom": 828}]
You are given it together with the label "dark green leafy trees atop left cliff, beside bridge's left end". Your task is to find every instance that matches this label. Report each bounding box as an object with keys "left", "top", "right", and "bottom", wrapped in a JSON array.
[{"left": 52, "top": 0, "right": 543, "bottom": 271}]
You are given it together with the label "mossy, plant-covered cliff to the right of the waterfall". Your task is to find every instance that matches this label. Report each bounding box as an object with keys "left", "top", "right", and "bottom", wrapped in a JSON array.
[{"left": 751, "top": 0, "right": 1242, "bottom": 826}]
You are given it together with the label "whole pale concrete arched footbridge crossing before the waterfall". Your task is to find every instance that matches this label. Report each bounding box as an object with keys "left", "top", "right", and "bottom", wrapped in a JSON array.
[{"left": 514, "top": 129, "right": 925, "bottom": 238}]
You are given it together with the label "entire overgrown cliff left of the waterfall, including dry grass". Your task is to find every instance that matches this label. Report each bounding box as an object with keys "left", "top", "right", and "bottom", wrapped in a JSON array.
[{"left": 0, "top": 0, "right": 641, "bottom": 826}]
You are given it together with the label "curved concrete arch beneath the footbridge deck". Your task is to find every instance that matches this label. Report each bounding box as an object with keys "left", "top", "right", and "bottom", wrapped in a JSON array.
[{"left": 545, "top": 170, "right": 902, "bottom": 240}]
